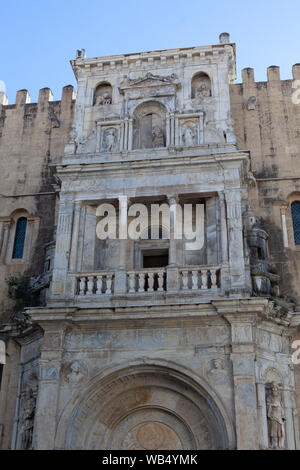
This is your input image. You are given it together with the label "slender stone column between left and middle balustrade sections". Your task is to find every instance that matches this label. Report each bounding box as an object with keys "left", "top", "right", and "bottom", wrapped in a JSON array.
[{"left": 115, "top": 196, "right": 128, "bottom": 294}]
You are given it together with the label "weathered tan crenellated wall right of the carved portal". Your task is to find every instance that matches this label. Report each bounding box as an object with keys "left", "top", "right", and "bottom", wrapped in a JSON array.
[{"left": 231, "top": 64, "right": 300, "bottom": 305}]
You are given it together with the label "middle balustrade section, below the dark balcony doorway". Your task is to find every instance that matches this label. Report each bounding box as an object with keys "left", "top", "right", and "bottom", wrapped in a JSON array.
[{"left": 127, "top": 268, "right": 166, "bottom": 294}]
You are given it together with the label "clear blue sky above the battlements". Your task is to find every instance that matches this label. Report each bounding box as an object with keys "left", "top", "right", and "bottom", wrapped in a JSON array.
[{"left": 0, "top": 0, "right": 300, "bottom": 104}]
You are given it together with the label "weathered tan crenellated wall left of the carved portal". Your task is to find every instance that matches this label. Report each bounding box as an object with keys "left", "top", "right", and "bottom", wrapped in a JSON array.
[{"left": 0, "top": 86, "right": 75, "bottom": 322}]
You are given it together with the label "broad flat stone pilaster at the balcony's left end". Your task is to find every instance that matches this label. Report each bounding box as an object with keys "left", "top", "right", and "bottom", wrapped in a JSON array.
[{"left": 52, "top": 199, "right": 74, "bottom": 295}]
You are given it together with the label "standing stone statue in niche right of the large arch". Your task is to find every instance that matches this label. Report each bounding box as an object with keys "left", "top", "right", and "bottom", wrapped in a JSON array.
[{"left": 267, "top": 382, "right": 285, "bottom": 449}]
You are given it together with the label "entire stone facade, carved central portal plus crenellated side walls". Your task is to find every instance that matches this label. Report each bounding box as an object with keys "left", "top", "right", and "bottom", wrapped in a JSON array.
[{"left": 0, "top": 33, "right": 300, "bottom": 450}]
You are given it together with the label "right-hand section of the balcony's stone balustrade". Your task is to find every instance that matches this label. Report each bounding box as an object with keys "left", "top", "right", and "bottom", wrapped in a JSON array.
[{"left": 179, "top": 266, "right": 221, "bottom": 291}]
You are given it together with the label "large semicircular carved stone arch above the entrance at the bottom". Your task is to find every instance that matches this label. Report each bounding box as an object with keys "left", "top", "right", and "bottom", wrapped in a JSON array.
[{"left": 56, "top": 366, "right": 232, "bottom": 450}]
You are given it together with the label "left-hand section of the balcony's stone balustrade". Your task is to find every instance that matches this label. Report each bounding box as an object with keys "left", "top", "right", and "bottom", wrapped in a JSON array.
[{"left": 77, "top": 272, "right": 114, "bottom": 296}]
